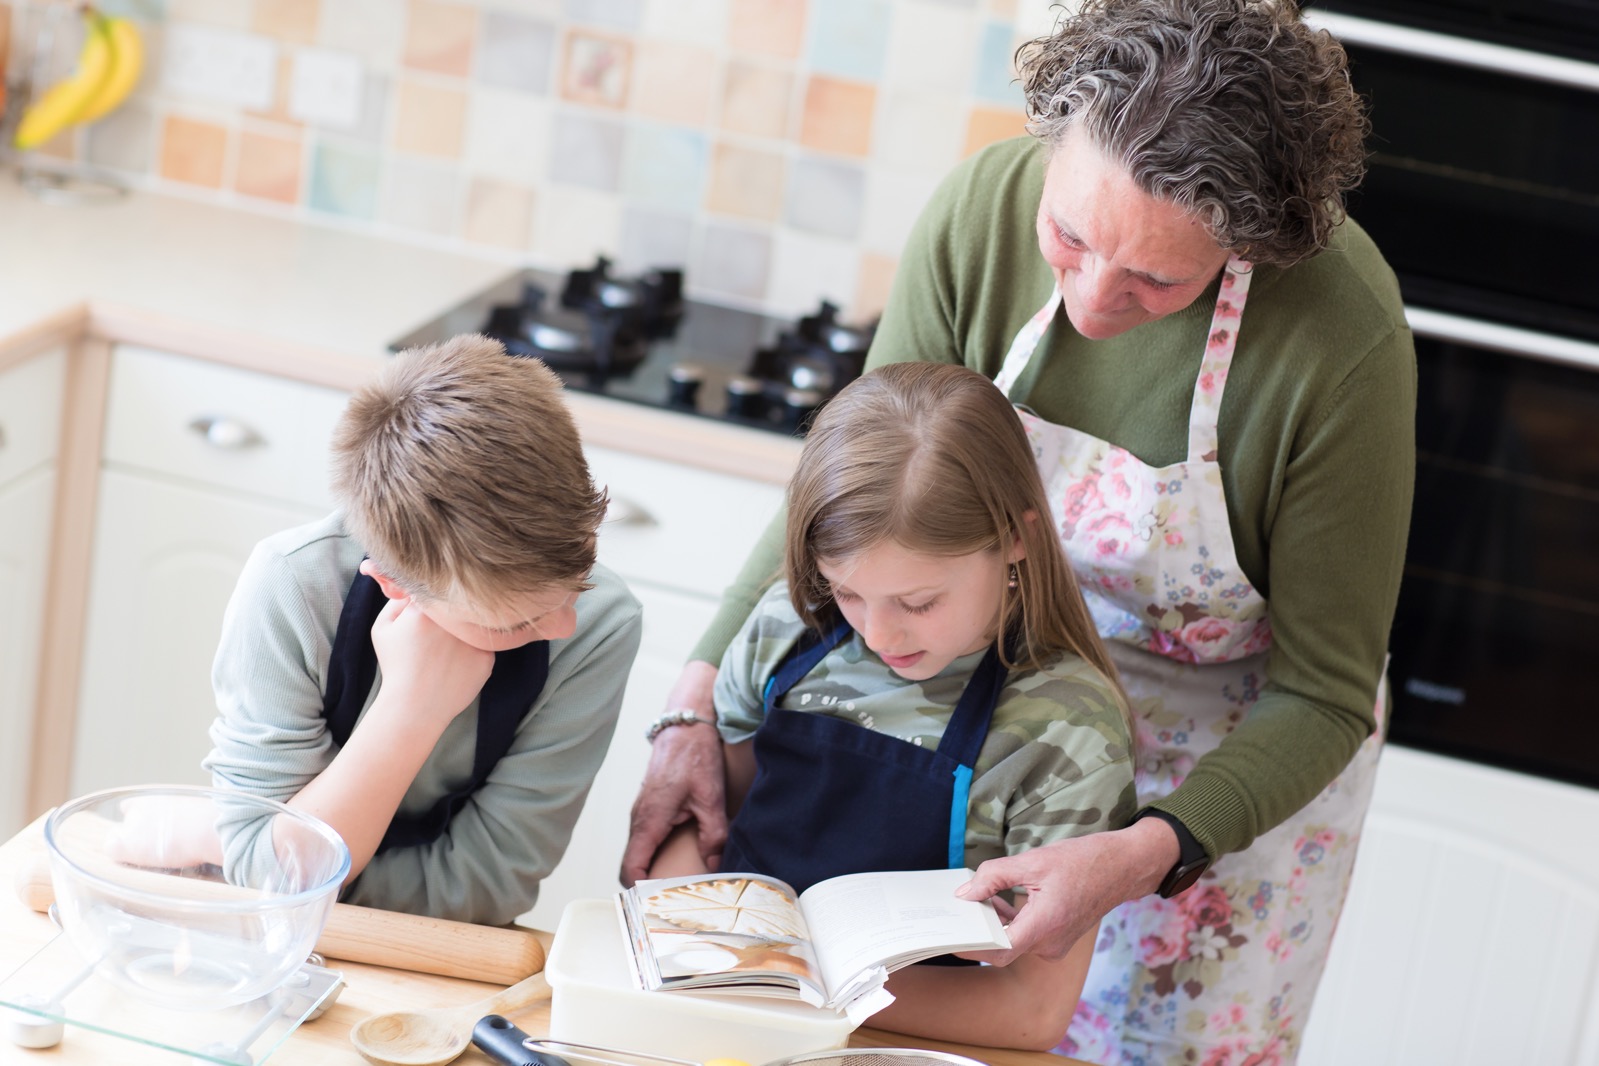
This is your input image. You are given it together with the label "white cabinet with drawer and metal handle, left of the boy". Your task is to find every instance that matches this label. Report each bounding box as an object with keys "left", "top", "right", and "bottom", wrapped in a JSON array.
[{"left": 70, "top": 345, "right": 345, "bottom": 794}]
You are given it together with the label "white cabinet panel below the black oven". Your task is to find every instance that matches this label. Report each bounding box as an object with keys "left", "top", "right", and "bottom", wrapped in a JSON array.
[{"left": 1300, "top": 745, "right": 1599, "bottom": 1066}]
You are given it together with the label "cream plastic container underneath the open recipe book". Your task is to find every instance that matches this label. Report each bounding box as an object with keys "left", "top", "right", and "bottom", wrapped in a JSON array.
[{"left": 544, "top": 900, "right": 854, "bottom": 1063}]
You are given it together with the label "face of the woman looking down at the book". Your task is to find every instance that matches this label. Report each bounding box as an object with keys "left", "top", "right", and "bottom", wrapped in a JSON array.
[{"left": 1038, "top": 128, "right": 1228, "bottom": 340}]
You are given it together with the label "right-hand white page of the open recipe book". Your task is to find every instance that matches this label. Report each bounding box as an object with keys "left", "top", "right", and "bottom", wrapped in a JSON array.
[{"left": 800, "top": 869, "right": 1011, "bottom": 996}]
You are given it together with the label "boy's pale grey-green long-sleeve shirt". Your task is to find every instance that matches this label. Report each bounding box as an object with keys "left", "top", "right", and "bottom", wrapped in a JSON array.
[{"left": 205, "top": 515, "right": 641, "bottom": 925}]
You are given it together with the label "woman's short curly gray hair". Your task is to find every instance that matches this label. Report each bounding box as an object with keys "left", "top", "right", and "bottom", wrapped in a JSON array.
[{"left": 1015, "top": 0, "right": 1369, "bottom": 265}]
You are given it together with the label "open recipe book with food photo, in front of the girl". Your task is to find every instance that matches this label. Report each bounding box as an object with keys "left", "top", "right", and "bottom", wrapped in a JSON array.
[{"left": 617, "top": 869, "right": 1011, "bottom": 1024}]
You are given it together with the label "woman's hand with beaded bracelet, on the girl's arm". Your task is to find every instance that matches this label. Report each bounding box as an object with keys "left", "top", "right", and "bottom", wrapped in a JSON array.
[{"left": 620, "top": 662, "right": 728, "bottom": 887}]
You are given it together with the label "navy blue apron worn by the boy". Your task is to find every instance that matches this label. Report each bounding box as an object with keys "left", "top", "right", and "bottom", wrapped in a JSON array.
[{"left": 321, "top": 574, "right": 550, "bottom": 855}]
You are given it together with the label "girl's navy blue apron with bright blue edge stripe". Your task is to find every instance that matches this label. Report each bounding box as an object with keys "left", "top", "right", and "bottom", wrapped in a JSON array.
[{"left": 721, "top": 622, "right": 1006, "bottom": 892}]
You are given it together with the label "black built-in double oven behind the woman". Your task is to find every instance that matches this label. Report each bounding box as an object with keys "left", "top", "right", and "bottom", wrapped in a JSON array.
[{"left": 1308, "top": 0, "right": 1599, "bottom": 786}]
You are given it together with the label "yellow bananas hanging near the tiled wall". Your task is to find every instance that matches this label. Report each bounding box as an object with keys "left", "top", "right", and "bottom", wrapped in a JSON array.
[{"left": 13, "top": 5, "right": 144, "bottom": 150}]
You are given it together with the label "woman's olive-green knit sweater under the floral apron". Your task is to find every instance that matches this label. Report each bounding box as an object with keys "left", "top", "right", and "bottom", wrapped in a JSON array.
[{"left": 694, "top": 137, "right": 1415, "bottom": 857}]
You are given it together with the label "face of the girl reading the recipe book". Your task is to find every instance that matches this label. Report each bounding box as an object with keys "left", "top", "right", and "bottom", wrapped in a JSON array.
[{"left": 817, "top": 540, "right": 1020, "bottom": 681}]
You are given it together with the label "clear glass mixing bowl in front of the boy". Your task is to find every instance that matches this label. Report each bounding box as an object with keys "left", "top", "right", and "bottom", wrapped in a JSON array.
[{"left": 45, "top": 786, "right": 350, "bottom": 1010}]
